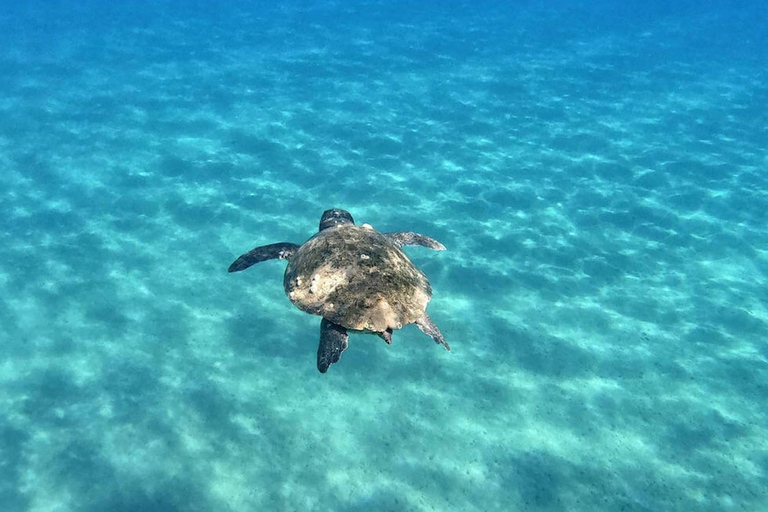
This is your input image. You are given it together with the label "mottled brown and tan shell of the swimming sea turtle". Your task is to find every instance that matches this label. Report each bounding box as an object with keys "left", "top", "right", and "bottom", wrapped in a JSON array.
[{"left": 283, "top": 224, "right": 432, "bottom": 332}]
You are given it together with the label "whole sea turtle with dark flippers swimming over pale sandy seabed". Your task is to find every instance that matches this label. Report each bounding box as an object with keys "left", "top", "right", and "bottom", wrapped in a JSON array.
[{"left": 229, "top": 209, "right": 451, "bottom": 373}]
